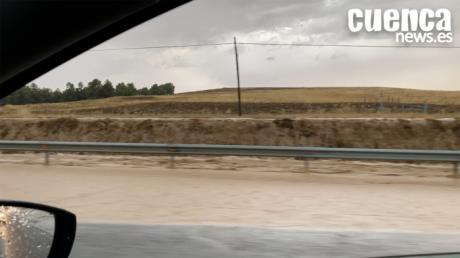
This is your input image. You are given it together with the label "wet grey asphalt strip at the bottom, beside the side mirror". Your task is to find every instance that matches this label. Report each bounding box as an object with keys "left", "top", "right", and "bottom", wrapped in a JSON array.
[{"left": 71, "top": 224, "right": 460, "bottom": 258}]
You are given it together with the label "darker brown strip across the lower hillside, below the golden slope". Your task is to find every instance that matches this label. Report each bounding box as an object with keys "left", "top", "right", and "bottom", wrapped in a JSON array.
[{"left": 70, "top": 102, "right": 460, "bottom": 115}]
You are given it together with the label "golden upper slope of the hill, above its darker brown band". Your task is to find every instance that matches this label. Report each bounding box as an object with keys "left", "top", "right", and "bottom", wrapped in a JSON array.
[{"left": 171, "top": 87, "right": 460, "bottom": 105}]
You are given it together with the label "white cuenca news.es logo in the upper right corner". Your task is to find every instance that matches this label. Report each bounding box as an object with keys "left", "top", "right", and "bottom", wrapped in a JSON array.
[{"left": 348, "top": 9, "right": 454, "bottom": 43}]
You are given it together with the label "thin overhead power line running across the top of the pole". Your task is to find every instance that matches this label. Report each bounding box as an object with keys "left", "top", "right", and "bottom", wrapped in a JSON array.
[{"left": 90, "top": 42, "right": 460, "bottom": 52}]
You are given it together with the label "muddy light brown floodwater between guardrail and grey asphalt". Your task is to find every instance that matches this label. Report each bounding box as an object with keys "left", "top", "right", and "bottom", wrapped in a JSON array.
[{"left": 0, "top": 154, "right": 460, "bottom": 232}]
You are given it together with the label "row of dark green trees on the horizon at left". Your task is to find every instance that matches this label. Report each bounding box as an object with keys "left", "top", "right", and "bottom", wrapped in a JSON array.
[{"left": 0, "top": 79, "right": 175, "bottom": 105}]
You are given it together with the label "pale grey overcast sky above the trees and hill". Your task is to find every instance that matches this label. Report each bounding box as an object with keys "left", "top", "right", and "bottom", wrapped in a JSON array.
[{"left": 35, "top": 0, "right": 460, "bottom": 92}]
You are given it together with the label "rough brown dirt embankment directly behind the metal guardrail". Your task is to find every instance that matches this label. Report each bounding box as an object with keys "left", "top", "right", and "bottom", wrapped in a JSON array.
[{"left": 0, "top": 118, "right": 460, "bottom": 149}]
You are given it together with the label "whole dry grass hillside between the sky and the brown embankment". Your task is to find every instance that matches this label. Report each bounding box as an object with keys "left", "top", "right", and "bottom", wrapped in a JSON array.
[{"left": 0, "top": 87, "right": 460, "bottom": 118}]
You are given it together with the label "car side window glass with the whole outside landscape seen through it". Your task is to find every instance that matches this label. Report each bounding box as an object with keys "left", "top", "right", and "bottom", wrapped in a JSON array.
[{"left": 0, "top": 0, "right": 460, "bottom": 257}]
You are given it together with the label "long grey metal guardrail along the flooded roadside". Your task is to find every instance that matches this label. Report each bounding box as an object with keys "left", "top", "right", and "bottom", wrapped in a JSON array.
[{"left": 0, "top": 141, "right": 460, "bottom": 176}]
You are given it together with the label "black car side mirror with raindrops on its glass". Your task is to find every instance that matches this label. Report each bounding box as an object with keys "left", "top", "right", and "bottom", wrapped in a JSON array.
[{"left": 0, "top": 201, "right": 77, "bottom": 258}]
